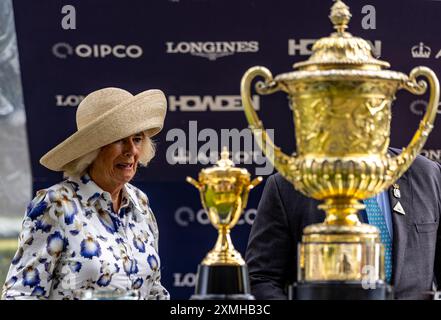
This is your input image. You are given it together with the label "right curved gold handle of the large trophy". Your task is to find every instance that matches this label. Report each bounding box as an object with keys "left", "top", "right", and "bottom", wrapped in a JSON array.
[{"left": 392, "top": 67, "right": 440, "bottom": 181}]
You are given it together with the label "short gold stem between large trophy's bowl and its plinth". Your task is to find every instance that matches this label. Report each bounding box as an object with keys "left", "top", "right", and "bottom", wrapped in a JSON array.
[{"left": 319, "top": 198, "right": 365, "bottom": 226}]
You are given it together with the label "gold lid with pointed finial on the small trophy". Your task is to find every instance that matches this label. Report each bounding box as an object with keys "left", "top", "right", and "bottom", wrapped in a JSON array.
[{"left": 199, "top": 147, "right": 250, "bottom": 182}]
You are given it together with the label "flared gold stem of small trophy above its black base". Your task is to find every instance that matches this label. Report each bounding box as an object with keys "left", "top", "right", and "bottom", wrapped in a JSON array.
[{"left": 202, "top": 227, "right": 245, "bottom": 266}]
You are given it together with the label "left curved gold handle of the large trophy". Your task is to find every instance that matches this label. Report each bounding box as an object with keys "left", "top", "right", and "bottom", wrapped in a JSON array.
[{"left": 240, "top": 66, "right": 295, "bottom": 178}]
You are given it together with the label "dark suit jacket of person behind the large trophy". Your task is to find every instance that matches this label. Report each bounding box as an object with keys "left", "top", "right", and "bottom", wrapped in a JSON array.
[{"left": 246, "top": 150, "right": 441, "bottom": 299}]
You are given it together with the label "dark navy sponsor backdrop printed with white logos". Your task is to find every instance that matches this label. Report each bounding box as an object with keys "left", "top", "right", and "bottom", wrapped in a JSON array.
[{"left": 10, "top": 0, "right": 441, "bottom": 299}]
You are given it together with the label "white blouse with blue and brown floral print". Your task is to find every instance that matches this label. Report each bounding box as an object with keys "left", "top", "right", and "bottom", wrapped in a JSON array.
[{"left": 2, "top": 174, "right": 170, "bottom": 299}]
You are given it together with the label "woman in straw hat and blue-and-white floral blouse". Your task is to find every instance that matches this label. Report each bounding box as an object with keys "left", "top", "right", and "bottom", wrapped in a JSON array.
[{"left": 2, "top": 88, "right": 169, "bottom": 299}]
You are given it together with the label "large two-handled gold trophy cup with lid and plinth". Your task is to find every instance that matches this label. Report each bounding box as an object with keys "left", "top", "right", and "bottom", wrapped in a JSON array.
[{"left": 241, "top": 0, "right": 439, "bottom": 299}]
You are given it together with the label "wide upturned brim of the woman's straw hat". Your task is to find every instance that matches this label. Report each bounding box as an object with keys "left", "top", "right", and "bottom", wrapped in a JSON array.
[{"left": 40, "top": 89, "right": 167, "bottom": 171}]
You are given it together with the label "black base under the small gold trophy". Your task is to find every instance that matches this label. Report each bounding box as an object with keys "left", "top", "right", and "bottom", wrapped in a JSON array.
[{"left": 190, "top": 265, "right": 254, "bottom": 300}]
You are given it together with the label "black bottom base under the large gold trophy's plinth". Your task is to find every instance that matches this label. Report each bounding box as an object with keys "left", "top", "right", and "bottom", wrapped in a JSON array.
[{"left": 289, "top": 281, "right": 393, "bottom": 300}]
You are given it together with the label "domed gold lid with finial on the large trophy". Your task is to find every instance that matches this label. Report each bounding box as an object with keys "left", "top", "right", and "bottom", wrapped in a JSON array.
[{"left": 293, "top": 0, "right": 390, "bottom": 70}]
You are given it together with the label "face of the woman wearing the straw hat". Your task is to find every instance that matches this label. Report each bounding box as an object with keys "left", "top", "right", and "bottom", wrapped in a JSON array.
[{"left": 90, "top": 133, "right": 145, "bottom": 186}]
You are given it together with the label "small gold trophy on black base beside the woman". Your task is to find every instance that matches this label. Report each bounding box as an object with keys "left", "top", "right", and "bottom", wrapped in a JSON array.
[{"left": 187, "top": 148, "right": 262, "bottom": 300}]
